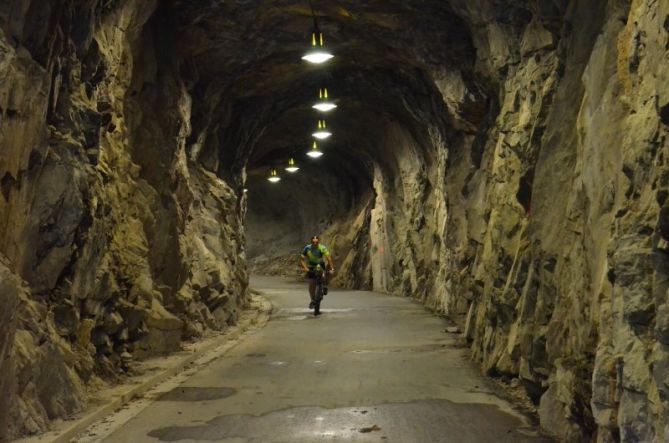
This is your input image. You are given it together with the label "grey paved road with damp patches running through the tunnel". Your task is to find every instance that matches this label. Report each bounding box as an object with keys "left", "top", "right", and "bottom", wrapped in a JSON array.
[{"left": 92, "top": 278, "right": 544, "bottom": 443}]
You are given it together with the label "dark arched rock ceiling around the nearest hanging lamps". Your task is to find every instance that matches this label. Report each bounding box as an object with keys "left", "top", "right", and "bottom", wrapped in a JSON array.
[{"left": 163, "top": 0, "right": 512, "bottom": 175}]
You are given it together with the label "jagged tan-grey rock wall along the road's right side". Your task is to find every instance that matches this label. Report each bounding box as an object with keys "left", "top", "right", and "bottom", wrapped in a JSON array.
[{"left": 243, "top": 0, "right": 669, "bottom": 441}]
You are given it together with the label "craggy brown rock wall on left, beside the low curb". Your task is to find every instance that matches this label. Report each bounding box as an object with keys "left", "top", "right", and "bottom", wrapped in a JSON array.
[{"left": 0, "top": 0, "right": 247, "bottom": 438}]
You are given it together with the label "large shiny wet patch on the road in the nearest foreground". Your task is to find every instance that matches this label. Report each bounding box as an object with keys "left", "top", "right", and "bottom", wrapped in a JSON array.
[{"left": 148, "top": 400, "right": 551, "bottom": 443}]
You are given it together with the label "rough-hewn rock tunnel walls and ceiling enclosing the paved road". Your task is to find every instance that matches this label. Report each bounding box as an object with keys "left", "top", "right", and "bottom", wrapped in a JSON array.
[{"left": 0, "top": 0, "right": 669, "bottom": 442}]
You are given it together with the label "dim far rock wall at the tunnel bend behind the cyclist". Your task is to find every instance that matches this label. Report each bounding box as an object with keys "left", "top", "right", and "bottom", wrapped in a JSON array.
[{"left": 245, "top": 153, "right": 373, "bottom": 284}]
